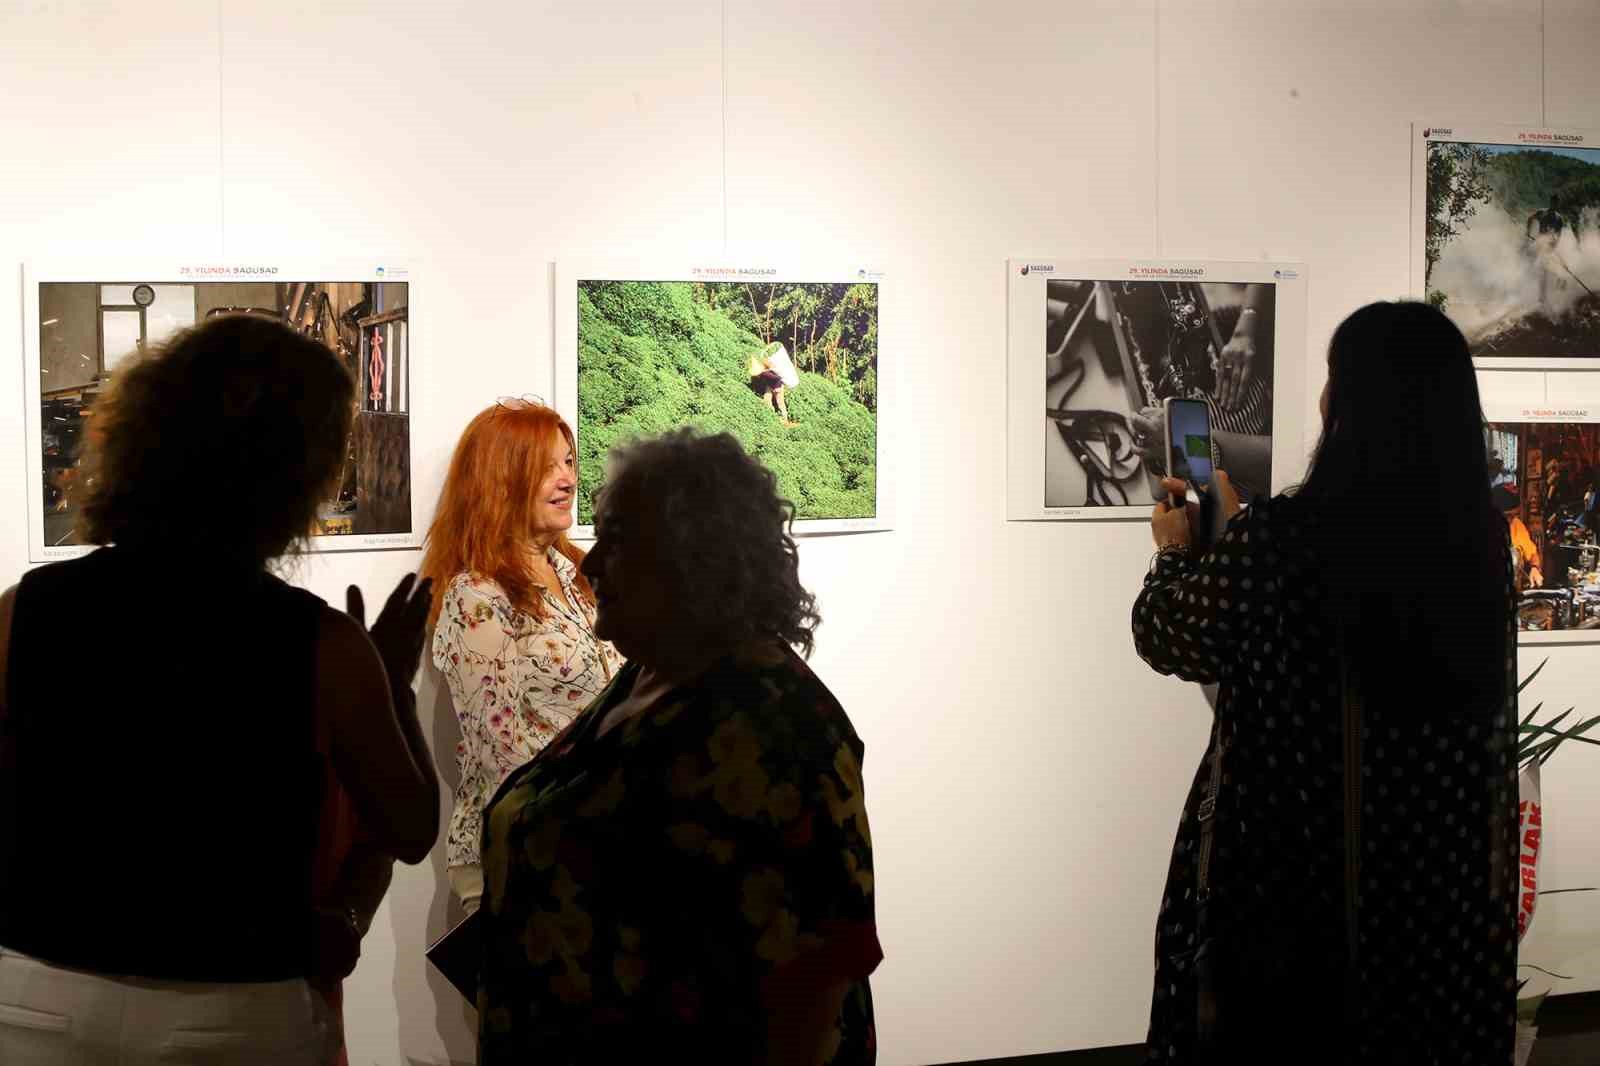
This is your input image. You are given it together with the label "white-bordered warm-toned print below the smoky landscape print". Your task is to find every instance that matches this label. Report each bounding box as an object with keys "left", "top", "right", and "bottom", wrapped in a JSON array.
[{"left": 1483, "top": 393, "right": 1600, "bottom": 643}]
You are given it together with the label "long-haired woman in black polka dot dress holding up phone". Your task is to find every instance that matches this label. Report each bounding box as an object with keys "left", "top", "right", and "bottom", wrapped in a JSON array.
[{"left": 1133, "top": 303, "right": 1517, "bottom": 1066}]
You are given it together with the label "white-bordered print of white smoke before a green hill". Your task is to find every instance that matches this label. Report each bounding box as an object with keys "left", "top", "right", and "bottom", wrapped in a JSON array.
[{"left": 1411, "top": 125, "right": 1600, "bottom": 368}]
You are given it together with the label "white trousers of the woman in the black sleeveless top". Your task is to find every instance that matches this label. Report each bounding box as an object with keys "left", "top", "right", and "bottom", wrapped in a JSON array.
[{"left": 0, "top": 948, "right": 328, "bottom": 1066}]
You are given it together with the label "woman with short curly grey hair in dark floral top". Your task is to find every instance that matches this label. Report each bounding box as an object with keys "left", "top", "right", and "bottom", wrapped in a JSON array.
[{"left": 478, "top": 431, "right": 882, "bottom": 1066}]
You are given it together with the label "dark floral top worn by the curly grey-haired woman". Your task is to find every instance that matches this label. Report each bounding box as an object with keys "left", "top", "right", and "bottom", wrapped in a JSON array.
[{"left": 478, "top": 645, "right": 883, "bottom": 1066}]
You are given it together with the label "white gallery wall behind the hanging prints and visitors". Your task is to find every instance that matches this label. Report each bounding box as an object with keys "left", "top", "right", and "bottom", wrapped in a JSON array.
[{"left": 0, "top": 0, "right": 1600, "bottom": 1066}]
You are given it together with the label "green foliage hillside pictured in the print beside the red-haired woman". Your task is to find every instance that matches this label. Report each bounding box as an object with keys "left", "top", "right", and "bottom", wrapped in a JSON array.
[{"left": 578, "top": 282, "right": 878, "bottom": 523}]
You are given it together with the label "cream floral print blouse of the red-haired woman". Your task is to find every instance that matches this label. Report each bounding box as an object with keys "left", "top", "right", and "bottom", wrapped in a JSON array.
[{"left": 434, "top": 549, "right": 622, "bottom": 866}]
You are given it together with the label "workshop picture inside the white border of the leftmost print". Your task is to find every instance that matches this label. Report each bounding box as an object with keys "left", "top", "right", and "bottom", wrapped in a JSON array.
[{"left": 37, "top": 280, "right": 411, "bottom": 547}]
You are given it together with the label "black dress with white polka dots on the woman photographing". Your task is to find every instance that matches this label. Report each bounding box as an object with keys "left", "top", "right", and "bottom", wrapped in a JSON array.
[{"left": 1133, "top": 496, "right": 1517, "bottom": 1066}]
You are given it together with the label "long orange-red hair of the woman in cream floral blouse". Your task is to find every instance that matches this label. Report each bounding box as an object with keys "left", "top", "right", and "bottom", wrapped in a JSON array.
[{"left": 419, "top": 400, "right": 594, "bottom": 626}]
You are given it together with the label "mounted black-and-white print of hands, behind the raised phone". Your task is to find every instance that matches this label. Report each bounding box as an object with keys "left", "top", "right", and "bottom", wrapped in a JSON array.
[{"left": 1006, "top": 259, "right": 1306, "bottom": 520}]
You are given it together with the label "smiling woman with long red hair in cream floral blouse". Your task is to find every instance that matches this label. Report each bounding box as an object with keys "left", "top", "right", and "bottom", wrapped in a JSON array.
[{"left": 422, "top": 393, "right": 621, "bottom": 912}]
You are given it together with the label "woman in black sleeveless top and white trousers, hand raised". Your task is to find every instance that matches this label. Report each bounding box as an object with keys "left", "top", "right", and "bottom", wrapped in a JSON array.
[{"left": 0, "top": 315, "right": 438, "bottom": 1066}]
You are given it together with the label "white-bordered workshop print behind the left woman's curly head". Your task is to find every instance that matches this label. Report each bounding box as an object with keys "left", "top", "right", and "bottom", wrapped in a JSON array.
[{"left": 22, "top": 262, "right": 422, "bottom": 562}]
